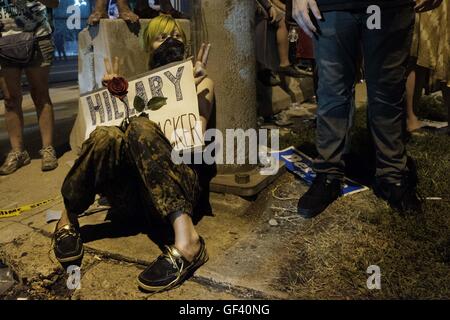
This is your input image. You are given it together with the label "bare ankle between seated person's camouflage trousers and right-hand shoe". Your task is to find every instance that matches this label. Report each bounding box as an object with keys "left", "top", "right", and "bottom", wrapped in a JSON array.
[{"left": 169, "top": 213, "right": 200, "bottom": 261}]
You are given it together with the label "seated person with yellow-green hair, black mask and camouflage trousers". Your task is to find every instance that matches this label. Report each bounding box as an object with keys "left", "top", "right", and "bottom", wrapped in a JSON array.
[{"left": 53, "top": 15, "right": 215, "bottom": 292}]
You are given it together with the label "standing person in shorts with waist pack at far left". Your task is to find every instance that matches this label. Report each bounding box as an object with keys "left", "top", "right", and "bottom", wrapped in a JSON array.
[{"left": 0, "top": 0, "right": 59, "bottom": 175}]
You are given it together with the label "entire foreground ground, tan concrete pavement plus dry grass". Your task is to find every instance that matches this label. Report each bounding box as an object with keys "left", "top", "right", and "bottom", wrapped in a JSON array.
[{"left": 0, "top": 94, "right": 450, "bottom": 300}]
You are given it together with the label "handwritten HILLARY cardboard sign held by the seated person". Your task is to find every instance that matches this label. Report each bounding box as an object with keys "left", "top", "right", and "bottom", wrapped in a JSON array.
[{"left": 71, "top": 60, "right": 203, "bottom": 150}]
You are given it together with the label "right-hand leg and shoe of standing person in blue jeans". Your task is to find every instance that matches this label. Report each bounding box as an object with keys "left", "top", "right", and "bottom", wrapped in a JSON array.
[{"left": 362, "top": 7, "right": 419, "bottom": 211}]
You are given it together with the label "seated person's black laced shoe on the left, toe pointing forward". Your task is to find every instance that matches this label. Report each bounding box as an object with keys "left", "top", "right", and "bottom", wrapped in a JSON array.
[{"left": 53, "top": 225, "right": 84, "bottom": 263}]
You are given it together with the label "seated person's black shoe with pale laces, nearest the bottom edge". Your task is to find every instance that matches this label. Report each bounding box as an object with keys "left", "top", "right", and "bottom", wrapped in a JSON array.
[{"left": 138, "top": 237, "right": 208, "bottom": 292}]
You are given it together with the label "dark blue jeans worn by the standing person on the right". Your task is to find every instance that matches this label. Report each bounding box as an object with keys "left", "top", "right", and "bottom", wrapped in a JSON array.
[{"left": 314, "top": 7, "right": 415, "bottom": 183}]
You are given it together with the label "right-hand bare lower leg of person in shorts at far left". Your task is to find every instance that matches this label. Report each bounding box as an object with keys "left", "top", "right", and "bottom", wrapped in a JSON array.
[{"left": 25, "top": 67, "right": 55, "bottom": 148}]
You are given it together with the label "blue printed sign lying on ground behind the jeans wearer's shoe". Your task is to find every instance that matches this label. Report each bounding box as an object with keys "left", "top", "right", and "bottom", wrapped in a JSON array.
[{"left": 271, "top": 147, "right": 369, "bottom": 196}]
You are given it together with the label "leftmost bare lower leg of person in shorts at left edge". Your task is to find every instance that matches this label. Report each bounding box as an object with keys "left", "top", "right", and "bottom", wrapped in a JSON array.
[{"left": 1, "top": 68, "right": 23, "bottom": 151}]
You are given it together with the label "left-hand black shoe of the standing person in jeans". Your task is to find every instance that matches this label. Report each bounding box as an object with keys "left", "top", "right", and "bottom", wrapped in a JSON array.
[{"left": 297, "top": 173, "right": 342, "bottom": 219}]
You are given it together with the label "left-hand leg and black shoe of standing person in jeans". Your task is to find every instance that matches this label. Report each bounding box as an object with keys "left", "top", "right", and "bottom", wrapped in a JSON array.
[{"left": 298, "top": 11, "right": 360, "bottom": 218}]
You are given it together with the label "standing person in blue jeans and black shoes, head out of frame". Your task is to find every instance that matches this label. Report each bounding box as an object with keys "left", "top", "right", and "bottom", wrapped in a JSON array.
[{"left": 293, "top": 0, "right": 440, "bottom": 218}]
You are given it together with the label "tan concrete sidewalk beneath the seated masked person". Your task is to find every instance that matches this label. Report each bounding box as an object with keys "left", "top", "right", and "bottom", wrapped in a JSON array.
[{"left": 0, "top": 152, "right": 316, "bottom": 299}]
